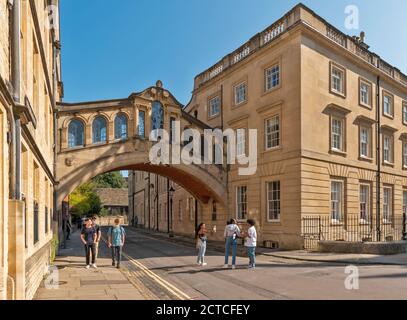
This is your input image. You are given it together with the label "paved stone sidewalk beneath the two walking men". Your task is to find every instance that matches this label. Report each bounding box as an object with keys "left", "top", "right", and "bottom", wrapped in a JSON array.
[{"left": 34, "top": 232, "right": 144, "bottom": 300}]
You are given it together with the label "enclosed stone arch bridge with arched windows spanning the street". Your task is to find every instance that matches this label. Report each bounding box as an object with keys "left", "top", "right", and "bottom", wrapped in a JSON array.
[{"left": 56, "top": 81, "right": 227, "bottom": 210}]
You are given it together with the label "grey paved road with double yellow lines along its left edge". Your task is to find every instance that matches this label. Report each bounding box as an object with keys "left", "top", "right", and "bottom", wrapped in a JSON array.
[{"left": 113, "top": 229, "right": 407, "bottom": 300}]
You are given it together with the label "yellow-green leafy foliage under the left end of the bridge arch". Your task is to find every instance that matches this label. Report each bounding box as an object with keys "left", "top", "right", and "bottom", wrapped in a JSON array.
[{"left": 69, "top": 182, "right": 102, "bottom": 216}]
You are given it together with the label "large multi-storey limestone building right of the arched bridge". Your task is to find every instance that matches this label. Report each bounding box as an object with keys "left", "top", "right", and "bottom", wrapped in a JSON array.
[{"left": 130, "top": 4, "right": 407, "bottom": 249}]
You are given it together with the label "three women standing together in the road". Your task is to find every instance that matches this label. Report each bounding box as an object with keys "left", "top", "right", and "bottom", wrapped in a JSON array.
[{"left": 196, "top": 219, "right": 257, "bottom": 269}]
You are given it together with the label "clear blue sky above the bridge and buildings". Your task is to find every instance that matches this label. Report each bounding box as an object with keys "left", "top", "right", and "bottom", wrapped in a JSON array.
[{"left": 61, "top": 0, "right": 407, "bottom": 104}]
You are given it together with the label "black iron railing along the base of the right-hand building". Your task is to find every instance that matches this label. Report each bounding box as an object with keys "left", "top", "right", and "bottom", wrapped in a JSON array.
[{"left": 301, "top": 215, "right": 407, "bottom": 250}]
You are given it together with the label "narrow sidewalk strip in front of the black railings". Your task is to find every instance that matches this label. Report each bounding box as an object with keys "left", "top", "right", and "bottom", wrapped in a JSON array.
[{"left": 263, "top": 250, "right": 407, "bottom": 265}]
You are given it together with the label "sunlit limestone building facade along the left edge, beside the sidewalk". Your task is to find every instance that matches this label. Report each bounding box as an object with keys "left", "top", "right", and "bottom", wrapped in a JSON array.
[{"left": 0, "top": 0, "right": 62, "bottom": 299}]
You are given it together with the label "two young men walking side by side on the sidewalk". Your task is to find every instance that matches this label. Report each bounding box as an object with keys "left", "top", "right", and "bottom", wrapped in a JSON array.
[{"left": 81, "top": 216, "right": 126, "bottom": 269}]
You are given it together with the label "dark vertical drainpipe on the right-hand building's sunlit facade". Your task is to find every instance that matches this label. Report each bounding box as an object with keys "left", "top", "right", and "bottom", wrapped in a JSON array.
[{"left": 376, "top": 76, "right": 381, "bottom": 241}]
